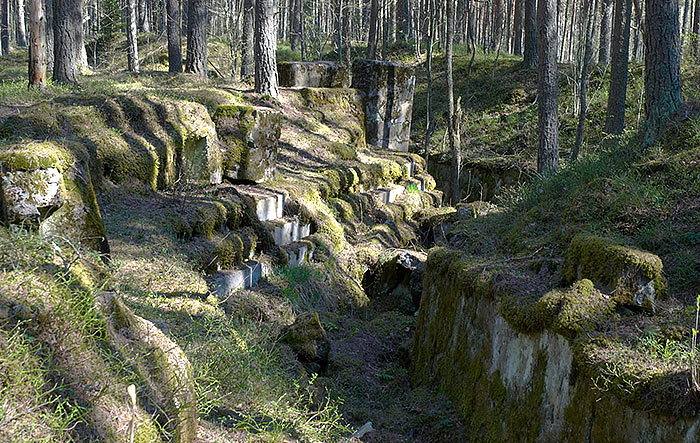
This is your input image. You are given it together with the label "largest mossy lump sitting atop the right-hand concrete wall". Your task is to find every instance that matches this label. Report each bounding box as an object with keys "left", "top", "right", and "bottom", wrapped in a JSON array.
[{"left": 562, "top": 234, "right": 668, "bottom": 310}]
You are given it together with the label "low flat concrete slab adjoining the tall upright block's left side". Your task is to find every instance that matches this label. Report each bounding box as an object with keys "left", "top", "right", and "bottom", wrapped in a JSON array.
[{"left": 277, "top": 61, "right": 350, "bottom": 88}]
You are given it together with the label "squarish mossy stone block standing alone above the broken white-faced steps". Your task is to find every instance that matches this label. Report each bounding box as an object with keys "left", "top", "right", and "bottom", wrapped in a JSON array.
[{"left": 214, "top": 105, "right": 282, "bottom": 183}]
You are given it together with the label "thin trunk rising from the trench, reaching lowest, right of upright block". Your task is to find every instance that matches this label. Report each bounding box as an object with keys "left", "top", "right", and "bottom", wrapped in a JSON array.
[{"left": 445, "top": 0, "right": 462, "bottom": 205}]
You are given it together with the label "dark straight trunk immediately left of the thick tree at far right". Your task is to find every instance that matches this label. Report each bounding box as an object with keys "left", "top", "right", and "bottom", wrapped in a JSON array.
[{"left": 605, "top": 0, "right": 632, "bottom": 134}]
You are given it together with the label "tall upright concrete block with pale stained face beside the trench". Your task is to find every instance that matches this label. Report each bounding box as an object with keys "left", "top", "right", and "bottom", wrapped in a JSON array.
[{"left": 352, "top": 60, "right": 416, "bottom": 152}]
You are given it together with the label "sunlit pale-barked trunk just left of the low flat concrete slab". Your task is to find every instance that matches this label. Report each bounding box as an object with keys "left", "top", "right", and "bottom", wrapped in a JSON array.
[{"left": 255, "top": 0, "right": 279, "bottom": 98}]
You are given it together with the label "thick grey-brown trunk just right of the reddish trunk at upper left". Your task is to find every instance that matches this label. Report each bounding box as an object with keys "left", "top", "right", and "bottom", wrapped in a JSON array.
[{"left": 53, "top": 0, "right": 85, "bottom": 84}]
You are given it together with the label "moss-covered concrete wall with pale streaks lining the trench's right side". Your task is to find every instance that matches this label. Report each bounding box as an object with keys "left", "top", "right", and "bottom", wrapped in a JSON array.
[{"left": 413, "top": 249, "right": 700, "bottom": 442}]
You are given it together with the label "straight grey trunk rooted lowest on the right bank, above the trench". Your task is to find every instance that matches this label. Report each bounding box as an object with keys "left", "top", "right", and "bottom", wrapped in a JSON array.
[{"left": 537, "top": 0, "right": 559, "bottom": 173}]
